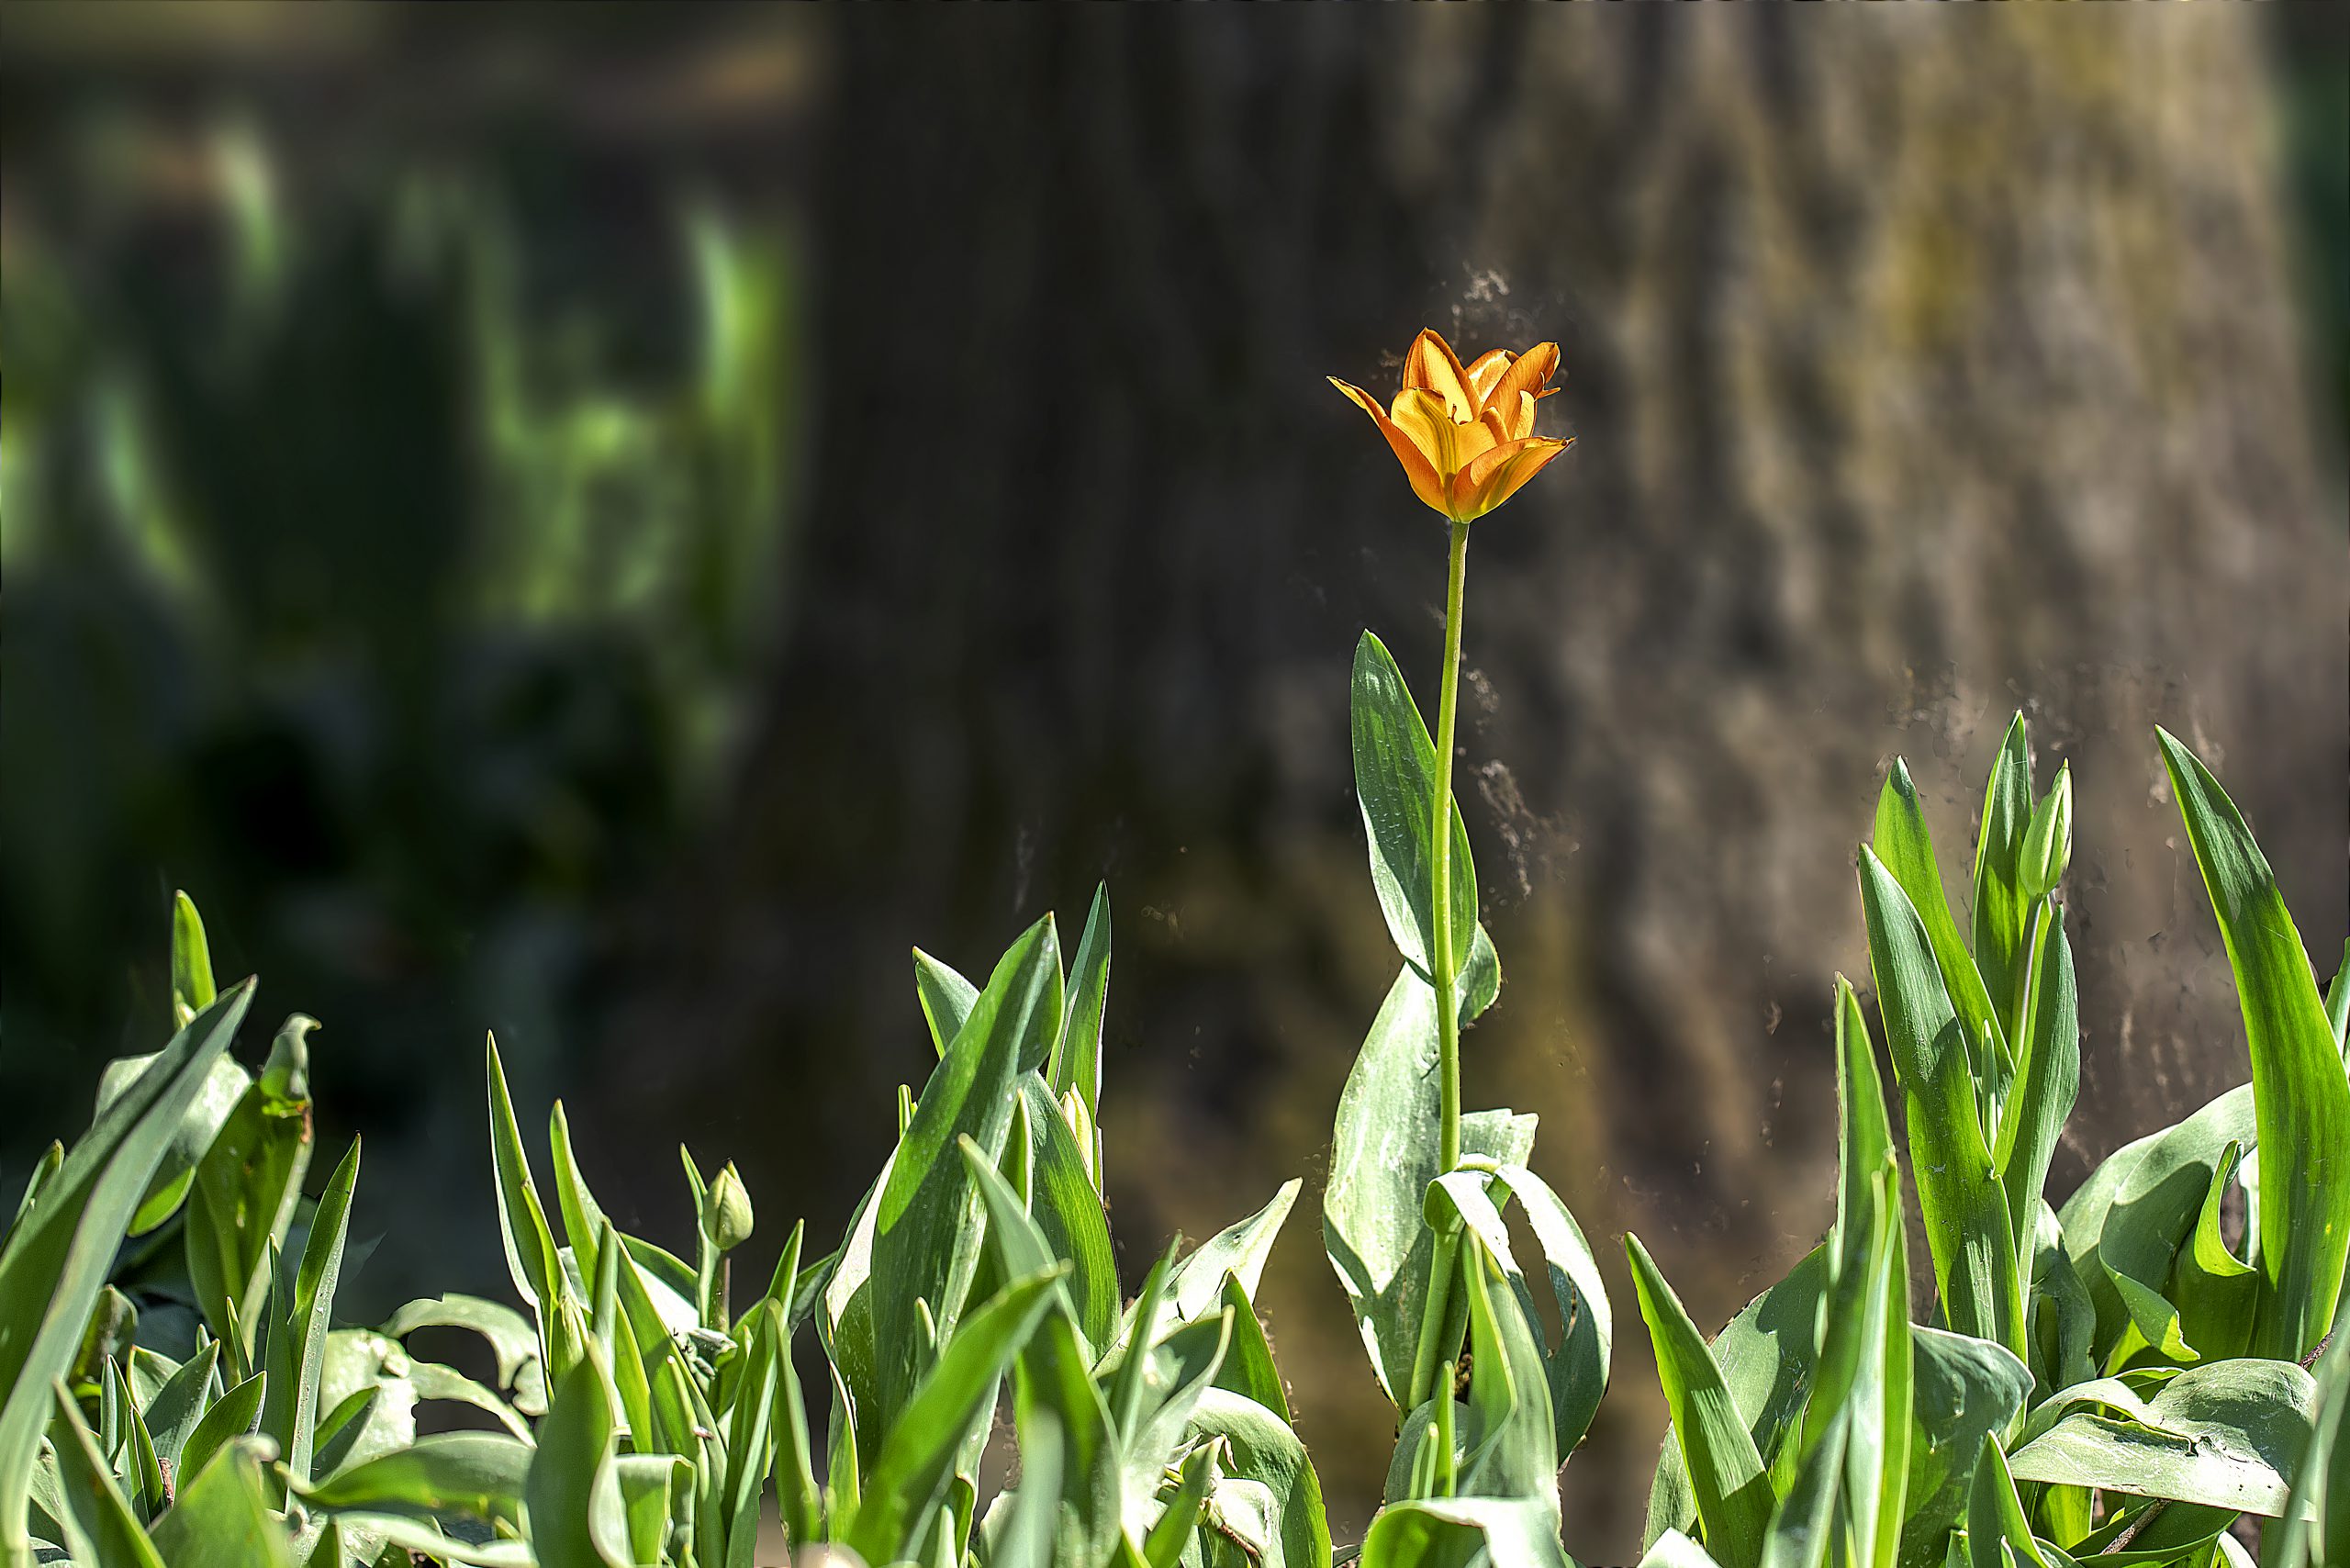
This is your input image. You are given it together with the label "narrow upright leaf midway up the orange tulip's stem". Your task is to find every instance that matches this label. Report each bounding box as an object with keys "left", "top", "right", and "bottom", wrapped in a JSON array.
[{"left": 1348, "top": 633, "right": 1476, "bottom": 976}]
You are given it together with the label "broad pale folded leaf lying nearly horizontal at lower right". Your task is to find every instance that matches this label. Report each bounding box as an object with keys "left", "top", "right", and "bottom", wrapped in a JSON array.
[{"left": 2009, "top": 1359, "right": 2317, "bottom": 1517}]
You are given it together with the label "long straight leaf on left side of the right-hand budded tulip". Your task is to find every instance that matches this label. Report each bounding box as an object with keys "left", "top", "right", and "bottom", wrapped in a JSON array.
[{"left": 1862, "top": 846, "right": 2023, "bottom": 1359}]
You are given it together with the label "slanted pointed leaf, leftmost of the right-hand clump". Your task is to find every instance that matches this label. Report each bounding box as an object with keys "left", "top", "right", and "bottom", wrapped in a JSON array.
[{"left": 1624, "top": 1234, "right": 1779, "bottom": 1568}]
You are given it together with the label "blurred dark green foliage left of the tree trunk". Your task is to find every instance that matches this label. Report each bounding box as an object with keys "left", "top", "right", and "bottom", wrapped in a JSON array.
[{"left": 0, "top": 118, "right": 799, "bottom": 1161}]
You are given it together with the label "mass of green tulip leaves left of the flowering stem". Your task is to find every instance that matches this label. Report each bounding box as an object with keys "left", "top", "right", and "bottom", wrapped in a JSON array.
[{"left": 0, "top": 893, "right": 1330, "bottom": 1568}]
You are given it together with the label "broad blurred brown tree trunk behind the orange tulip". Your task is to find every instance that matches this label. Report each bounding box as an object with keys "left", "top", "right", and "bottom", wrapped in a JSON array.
[{"left": 601, "top": 7, "right": 2350, "bottom": 1561}]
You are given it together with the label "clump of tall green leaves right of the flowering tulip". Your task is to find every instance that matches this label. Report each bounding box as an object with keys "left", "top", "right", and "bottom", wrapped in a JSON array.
[{"left": 1628, "top": 714, "right": 2350, "bottom": 1568}]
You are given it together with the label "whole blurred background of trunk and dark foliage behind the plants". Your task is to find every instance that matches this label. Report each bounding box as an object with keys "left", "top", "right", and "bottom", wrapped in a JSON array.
[{"left": 0, "top": 5, "right": 2350, "bottom": 1561}]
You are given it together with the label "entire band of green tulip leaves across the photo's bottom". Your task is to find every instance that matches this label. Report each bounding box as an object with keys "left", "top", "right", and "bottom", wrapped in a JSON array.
[{"left": 0, "top": 710, "right": 2350, "bottom": 1568}]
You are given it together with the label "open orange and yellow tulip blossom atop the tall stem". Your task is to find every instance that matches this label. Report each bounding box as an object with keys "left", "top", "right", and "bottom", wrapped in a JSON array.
[{"left": 1330, "top": 330, "right": 1570, "bottom": 521}]
